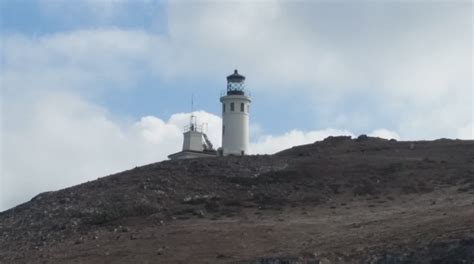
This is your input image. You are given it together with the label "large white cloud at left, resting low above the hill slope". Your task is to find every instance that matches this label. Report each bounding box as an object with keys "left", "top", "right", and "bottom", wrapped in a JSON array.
[{"left": 0, "top": 89, "right": 221, "bottom": 210}]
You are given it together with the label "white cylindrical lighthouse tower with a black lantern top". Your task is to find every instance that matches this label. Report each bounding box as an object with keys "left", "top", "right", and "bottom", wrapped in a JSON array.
[{"left": 221, "top": 70, "right": 252, "bottom": 156}]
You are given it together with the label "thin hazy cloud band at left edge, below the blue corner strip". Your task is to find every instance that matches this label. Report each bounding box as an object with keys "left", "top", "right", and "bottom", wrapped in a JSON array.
[{"left": 1, "top": 29, "right": 159, "bottom": 96}]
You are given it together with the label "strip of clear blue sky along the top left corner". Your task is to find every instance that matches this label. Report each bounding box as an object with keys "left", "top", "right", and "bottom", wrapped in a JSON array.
[{"left": 2, "top": 0, "right": 166, "bottom": 35}]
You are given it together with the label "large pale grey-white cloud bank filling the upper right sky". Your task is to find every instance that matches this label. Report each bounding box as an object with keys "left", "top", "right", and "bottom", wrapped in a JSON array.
[{"left": 161, "top": 1, "right": 474, "bottom": 139}]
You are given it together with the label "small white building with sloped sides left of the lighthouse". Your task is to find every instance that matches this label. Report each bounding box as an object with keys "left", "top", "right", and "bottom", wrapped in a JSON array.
[{"left": 168, "top": 115, "right": 217, "bottom": 160}]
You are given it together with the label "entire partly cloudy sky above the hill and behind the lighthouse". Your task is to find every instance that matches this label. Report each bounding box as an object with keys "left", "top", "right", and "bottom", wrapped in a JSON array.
[{"left": 0, "top": 0, "right": 474, "bottom": 211}]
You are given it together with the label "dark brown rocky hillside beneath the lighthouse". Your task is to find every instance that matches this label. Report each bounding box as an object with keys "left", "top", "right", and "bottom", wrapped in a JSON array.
[{"left": 0, "top": 136, "right": 474, "bottom": 263}]
